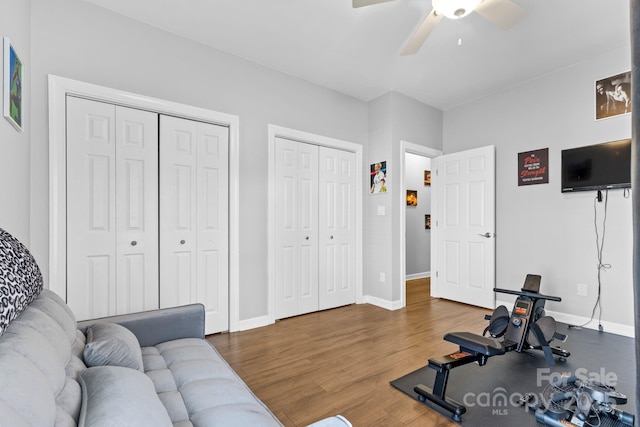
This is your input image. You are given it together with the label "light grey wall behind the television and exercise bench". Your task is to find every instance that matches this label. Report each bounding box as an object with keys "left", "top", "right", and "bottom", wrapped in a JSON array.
[{"left": 443, "top": 48, "right": 634, "bottom": 334}]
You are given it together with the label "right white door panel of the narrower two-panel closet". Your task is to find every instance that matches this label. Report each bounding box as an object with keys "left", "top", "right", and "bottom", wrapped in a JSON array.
[{"left": 319, "top": 147, "right": 357, "bottom": 310}]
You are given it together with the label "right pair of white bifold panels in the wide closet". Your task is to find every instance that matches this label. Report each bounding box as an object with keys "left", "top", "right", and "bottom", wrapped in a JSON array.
[{"left": 160, "top": 115, "right": 229, "bottom": 334}]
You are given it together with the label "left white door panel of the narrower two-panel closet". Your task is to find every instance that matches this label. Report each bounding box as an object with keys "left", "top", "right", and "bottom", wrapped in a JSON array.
[{"left": 274, "top": 138, "right": 318, "bottom": 319}]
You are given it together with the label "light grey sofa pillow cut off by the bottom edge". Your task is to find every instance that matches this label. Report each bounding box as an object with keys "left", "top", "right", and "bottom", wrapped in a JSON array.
[{"left": 78, "top": 366, "right": 172, "bottom": 427}]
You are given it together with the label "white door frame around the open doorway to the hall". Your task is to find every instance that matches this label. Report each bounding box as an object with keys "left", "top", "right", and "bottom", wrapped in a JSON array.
[{"left": 394, "top": 141, "right": 442, "bottom": 309}]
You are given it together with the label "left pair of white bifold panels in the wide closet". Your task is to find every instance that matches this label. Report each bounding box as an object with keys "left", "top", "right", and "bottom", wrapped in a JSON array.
[{"left": 66, "top": 97, "right": 158, "bottom": 320}]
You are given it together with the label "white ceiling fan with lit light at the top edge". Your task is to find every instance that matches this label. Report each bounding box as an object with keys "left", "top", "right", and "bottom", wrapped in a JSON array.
[{"left": 353, "top": 0, "right": 527, "bottom": 56}]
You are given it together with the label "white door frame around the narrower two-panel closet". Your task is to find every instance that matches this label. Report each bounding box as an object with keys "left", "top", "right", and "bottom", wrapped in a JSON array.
[{"left": 267, "top": 124, "right": 364, "bottom": 323}]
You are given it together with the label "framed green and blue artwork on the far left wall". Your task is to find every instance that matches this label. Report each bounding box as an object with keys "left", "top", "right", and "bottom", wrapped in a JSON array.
[{"left": 3, "top": 37, "right": 24, "bottom": 132}]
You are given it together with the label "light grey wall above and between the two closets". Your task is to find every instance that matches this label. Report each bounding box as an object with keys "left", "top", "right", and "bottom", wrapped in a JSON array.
[{"left": 30, "top": 0, "right": 368, "bottom": 320}]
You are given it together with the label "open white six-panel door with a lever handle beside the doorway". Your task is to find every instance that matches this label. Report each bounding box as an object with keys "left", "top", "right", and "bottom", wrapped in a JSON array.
[{"left": 431, "top": 146, "right": 495, "bottom": 308}]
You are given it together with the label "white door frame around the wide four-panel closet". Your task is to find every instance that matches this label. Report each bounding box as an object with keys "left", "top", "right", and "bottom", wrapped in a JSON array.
[{"left": 48, "top": 74, "right": 240, "bottom": 332}]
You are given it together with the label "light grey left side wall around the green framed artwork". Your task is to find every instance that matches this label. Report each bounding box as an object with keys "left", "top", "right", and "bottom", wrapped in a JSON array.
[{"left": 0, "top": 0, "right": 32, "bottom": 246}]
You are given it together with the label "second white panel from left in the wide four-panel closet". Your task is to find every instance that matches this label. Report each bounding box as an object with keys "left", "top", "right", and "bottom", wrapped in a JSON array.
[{"left": 116, "top": 107, "right": 159, "bottom": 314}]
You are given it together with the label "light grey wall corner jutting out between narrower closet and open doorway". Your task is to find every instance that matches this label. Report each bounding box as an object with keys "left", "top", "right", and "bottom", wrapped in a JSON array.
[{"left": 363, "top": 92, "right": 442, "bottom": 308}]
